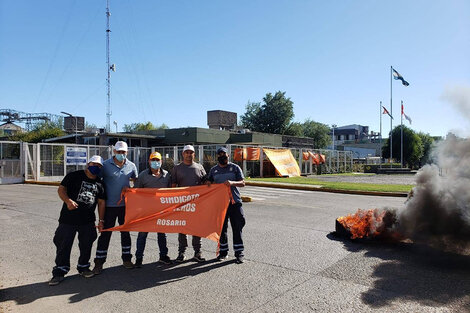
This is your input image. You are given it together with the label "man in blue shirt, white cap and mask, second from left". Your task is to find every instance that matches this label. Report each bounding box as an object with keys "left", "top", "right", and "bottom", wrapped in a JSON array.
[{"left": 93, "top": 141, "right": 138, "bottom": 275}]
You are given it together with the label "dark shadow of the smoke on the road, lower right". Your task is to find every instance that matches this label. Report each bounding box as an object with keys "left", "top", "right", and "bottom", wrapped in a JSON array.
[{"left": 327, "top": 233, "right": 470, "bottom": 312}]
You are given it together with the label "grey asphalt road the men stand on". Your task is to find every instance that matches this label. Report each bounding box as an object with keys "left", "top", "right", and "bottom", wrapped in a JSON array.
[{"left": 0, "top": 185, "right": 470, "bottom": 313}]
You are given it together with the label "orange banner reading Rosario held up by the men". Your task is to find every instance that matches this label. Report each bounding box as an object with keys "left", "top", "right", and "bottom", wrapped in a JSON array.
[{"left": 104, "top": 184, "right": 232, "bottom": 242}]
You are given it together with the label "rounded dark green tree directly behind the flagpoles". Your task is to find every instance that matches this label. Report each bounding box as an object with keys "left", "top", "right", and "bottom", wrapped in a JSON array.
[{"left": 382, "top": 126, "right": 423, "bottom": 168}]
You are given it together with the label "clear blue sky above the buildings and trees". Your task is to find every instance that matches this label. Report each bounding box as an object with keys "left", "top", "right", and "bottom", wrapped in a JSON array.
[{"left": 0, "top": 0, "right": 470, "bottom": 136}]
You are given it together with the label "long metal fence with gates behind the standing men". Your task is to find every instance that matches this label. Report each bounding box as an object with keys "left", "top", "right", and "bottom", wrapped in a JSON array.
[{"left": 0, "top": 141, "right": 353, "bottom": 184}]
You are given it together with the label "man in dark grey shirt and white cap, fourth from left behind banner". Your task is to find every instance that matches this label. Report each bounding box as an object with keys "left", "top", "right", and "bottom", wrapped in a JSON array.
[{"left": 171, "top": 145, "right": 206, "bottom": 263}]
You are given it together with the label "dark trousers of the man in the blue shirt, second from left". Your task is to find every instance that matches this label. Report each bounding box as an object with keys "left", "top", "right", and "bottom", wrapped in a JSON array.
[{"left": 95, "top": 206, "right": 132, "bottom": 263}]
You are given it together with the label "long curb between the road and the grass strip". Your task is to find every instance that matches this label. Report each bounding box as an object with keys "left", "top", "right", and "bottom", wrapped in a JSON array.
[{"left": 245, "top": 181, "right": 408, "bottom": 198}]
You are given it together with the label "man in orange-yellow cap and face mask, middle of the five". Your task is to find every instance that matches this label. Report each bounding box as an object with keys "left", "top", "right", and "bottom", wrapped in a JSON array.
[{"left": 134, "top": 151, "right": 171, "bottom": 267}]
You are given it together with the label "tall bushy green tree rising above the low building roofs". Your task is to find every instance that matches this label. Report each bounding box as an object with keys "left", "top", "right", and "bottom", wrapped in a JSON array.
[{"left": 241, "top": 91, "right": 294, "bottom": 134}]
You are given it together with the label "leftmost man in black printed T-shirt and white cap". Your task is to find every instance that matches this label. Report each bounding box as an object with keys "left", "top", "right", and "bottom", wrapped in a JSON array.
[{"left": 49, "top": 155, "right": 105, "bottom": 286}]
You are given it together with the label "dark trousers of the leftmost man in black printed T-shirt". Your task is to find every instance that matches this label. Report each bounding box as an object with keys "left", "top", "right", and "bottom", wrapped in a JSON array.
[{"left": 52, "top": 222, "right": 97, "bottom": 276}]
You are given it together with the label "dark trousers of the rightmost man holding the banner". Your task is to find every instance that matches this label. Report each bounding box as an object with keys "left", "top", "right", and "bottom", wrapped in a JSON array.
[{"left": 219, "top": 203, "right": 245, "bottom": 256}]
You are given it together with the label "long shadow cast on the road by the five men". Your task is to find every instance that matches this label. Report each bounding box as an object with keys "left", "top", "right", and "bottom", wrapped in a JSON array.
[{"left": 0, "top": 259, "right": 235, "bottom": 305}]
